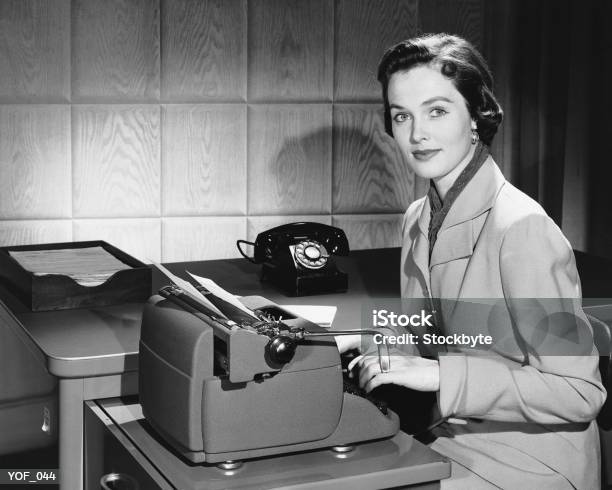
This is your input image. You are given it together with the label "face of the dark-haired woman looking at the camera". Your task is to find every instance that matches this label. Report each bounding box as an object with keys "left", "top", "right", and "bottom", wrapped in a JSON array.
[{"left": 387, "top": 65, "right": 475, "bottom": 198}]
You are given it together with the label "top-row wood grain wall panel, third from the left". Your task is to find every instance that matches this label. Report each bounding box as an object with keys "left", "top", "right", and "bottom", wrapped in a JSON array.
[{"left": 161, "top": 0, "right": 247, "bottom": 102}]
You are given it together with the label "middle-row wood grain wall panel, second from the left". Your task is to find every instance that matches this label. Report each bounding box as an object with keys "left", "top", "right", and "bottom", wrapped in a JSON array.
[{"left": 72, "top": 105, "right": 160, "bottom": 218}]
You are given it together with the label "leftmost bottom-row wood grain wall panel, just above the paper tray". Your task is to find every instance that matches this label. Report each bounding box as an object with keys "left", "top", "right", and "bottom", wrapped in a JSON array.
[{"left": 0, "top": 220, "right": 72, "bottom": 247}]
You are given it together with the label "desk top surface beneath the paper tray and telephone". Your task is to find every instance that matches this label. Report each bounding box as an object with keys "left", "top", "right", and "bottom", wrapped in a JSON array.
[{"left": 0, "top": 249, "right": 399, "bottom": 378}]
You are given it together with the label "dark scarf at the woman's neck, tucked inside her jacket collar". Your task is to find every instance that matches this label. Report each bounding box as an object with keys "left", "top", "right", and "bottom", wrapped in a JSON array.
[{"left": 427, "top": 142, "right": 489, "bottom": 259}]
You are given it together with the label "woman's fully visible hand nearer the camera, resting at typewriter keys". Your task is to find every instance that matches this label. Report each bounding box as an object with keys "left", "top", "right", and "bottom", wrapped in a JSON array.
[{"left": 348, "top": 354, "right": 440, "bottom": 392}]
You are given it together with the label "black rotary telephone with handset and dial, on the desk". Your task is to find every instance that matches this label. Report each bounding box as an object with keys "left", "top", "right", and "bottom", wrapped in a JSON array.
[{"left": 236, "top": 222, "right": 349, "bottom": 296}]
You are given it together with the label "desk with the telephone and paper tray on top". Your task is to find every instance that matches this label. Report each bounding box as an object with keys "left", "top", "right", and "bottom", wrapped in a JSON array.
[{"left": 0, "top": 249, "right": 450, "bottom": 489}]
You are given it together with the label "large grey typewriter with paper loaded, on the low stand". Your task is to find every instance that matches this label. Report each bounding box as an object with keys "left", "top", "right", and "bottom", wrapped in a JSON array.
[{"left": 139, "top": 286, "right": 399, "bottom": 469}]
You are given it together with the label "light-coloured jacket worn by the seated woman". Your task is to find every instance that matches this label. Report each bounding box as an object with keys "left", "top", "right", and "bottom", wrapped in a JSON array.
[{"left": 401, "top": 157, "right": 606, "bottom": 489}]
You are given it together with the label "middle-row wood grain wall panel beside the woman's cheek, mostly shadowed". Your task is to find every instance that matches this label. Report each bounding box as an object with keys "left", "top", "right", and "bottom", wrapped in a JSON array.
[{"left": 333, "top": 104, "right": 414, "bottom": 213}]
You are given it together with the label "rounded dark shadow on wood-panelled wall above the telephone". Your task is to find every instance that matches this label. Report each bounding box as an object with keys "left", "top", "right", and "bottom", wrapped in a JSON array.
[{"left": 264, "top": 125, "right": 414, "bottom": 214}]
